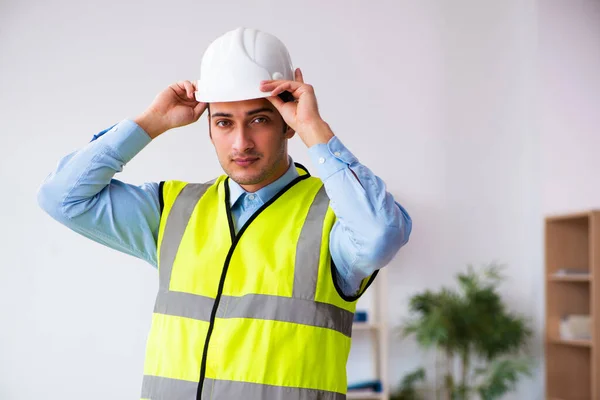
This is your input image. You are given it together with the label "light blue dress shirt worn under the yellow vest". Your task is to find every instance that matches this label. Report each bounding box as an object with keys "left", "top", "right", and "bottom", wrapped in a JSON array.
[{"left": 38, "top": 119, "right": 412, "bottom": 296}]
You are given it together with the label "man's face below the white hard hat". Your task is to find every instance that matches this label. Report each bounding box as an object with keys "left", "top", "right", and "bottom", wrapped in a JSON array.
[{"left": 209, "top": 99, "right": 294, "bottom": 192}]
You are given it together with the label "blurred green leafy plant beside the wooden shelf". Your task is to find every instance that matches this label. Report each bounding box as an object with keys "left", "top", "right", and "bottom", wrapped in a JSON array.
[{"left": 392, "top": 264, "right": 532, "bottom": 400}]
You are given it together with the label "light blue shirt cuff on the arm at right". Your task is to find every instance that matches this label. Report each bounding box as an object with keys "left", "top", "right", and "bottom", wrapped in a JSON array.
[{"left": 308, "top": 136, "right": 358, "bottom": 181}]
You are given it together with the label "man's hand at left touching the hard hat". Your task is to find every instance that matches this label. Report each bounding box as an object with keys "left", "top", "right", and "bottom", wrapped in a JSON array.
[{"left": 134, "top": 81, "right": 207, "bottom": 139}]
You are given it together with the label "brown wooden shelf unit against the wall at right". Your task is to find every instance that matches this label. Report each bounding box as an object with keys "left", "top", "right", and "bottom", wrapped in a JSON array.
[{"left": 545, "top": 210, "right": 600, "bottom": 400}]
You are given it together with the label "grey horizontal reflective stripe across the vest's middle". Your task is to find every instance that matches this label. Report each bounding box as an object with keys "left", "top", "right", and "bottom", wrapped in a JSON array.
[{"left": 154, "top": 292, "right": 354, "bottom": 337}]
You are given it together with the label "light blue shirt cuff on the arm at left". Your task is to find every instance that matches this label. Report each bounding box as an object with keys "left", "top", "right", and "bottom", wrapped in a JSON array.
[{"left": 98, "top": 119, "right": 152, "bottom": 163}]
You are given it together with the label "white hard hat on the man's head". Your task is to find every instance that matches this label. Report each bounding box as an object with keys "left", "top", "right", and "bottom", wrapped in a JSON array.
[{"left": 196, "top": 28, "right": 294, "bottom": 103}]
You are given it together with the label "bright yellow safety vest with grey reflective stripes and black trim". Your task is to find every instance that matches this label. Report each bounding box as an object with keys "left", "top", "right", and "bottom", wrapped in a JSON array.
[{"left": 142, "top": 164, "right": 375, "bottom": 400}]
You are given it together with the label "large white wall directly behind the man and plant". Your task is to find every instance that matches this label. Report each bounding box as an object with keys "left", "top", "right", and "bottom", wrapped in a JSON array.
[{"left": 0, "top": 0, "right": 568, "bottom": 400}]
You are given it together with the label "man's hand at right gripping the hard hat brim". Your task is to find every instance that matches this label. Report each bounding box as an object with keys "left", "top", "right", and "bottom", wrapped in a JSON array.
[{"left": 260, "top": 68, "right": 333, "bottom": 147}]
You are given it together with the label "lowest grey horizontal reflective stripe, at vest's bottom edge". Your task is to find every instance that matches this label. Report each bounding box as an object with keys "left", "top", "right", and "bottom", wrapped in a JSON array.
[{"left": 142, "top": 375, "right": 346, "bottom": 400}]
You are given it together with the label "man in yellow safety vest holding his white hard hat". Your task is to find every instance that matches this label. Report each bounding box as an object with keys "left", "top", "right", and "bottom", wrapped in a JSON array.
[{"left": 38, "top": 28, "right": 412, "bottom": 400}]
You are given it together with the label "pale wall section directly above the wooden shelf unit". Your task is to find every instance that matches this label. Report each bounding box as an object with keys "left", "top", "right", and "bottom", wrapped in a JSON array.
[{"left": 539, "top": 0, "right": 600, "bottom": 213}]
